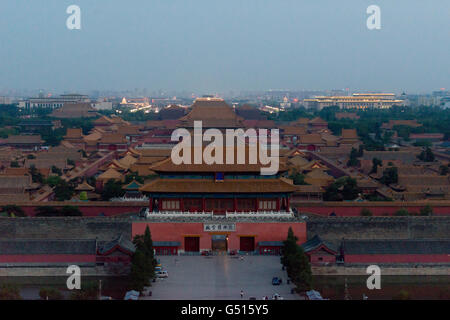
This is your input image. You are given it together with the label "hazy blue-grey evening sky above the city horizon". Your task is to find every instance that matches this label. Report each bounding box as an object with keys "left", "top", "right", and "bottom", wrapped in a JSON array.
[{"left": 0, "top": 0, "right": 450, "bottom": 93}]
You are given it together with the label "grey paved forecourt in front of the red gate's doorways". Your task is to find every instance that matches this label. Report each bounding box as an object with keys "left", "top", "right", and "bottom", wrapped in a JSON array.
[{"left": 143, "top": 255, "right": 300, "bottom": 300}]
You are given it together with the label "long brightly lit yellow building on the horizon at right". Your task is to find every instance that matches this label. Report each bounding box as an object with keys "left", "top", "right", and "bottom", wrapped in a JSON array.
[{"left": 303, "top": 93, "right": 404, "bottom": 110}]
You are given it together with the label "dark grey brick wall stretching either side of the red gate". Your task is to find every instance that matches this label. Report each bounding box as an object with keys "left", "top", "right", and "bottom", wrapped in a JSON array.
[{"left": 0, "top": 217, "right": 450, "bottom": 241}]
